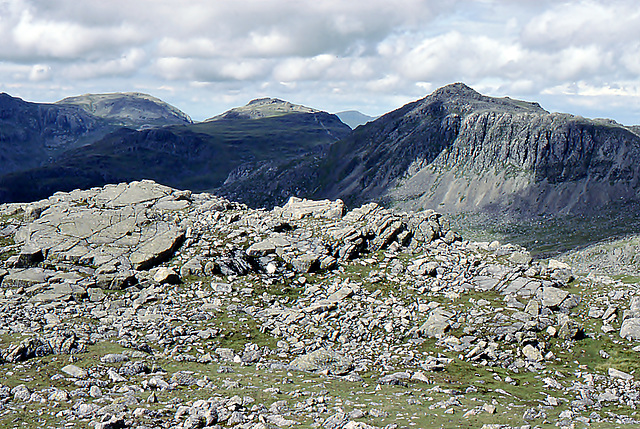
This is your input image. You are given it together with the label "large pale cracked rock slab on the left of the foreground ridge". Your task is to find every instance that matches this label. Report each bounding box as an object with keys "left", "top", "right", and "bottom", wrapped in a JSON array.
[{"left": 15, "top": 181, "right": 184, "bottom": 270}]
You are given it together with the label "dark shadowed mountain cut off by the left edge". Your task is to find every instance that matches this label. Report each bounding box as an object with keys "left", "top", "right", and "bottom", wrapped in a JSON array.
[{"left": 0, "top": 93, "right": 115, "bottom": 176}]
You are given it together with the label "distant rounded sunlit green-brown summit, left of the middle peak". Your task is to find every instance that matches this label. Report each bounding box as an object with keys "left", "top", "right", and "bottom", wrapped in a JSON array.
[{"left": 56, "top": 92, "right": 193, "bottom": 128}]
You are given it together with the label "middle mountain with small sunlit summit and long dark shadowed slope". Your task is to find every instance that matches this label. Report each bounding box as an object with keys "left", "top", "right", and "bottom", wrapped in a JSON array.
[{"left": 0, "top": 99, "right": 351, "bottom": 201}]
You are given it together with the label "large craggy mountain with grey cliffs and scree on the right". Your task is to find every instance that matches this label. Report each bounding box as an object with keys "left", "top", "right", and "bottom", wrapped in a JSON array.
[{"left": 321, "top": 84, "right": 640, "bottom": 214}]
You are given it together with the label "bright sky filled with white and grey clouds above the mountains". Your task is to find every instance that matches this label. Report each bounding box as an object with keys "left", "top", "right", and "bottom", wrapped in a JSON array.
[{"left": 0, "top": 0, "right": 640, "bottom": 125}]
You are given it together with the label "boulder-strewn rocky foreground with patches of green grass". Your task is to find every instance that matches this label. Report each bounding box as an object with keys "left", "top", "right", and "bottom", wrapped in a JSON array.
[{"left": 0, "top": 181, "right": 640, "bottom": 429}]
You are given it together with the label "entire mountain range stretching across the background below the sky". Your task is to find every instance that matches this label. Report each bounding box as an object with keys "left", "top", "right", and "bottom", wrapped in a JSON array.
[{"left": 0, "top": 83, "right": 640, "bottom": 249}]
